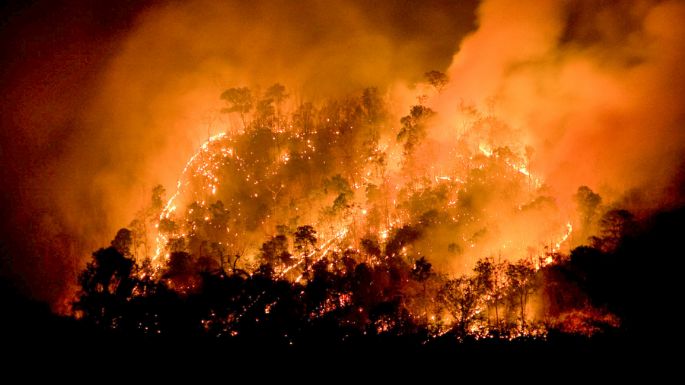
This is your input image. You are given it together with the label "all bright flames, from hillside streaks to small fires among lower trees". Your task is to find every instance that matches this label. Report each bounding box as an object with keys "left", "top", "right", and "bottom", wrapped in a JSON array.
[{"left": 142, "top": 121, "right": 584, "bottom": 338}]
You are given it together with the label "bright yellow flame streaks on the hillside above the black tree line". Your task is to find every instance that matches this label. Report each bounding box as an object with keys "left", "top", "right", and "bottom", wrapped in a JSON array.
[{"left": 147, "top": 118, "right": 572, "bottom": 281}]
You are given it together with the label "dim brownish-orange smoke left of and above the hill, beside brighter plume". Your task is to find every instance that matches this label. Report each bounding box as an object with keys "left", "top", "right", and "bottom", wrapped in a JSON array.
[{"left": 0, "top": 1, "right": 475, "bottom": 303}]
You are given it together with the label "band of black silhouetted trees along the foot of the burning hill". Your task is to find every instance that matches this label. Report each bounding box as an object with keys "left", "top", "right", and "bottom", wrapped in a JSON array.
[{"left": 69, "top": 204, "right": 672, "bottom": 345}]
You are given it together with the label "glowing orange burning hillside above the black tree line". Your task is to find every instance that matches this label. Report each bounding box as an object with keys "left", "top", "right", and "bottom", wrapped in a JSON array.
[{"left": 147, "top": 83, "right": 572, "bottom": 280}]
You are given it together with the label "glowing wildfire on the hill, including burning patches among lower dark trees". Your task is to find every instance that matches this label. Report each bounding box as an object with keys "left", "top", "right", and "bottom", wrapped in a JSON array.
[{"left": 95, "top": 89, "right": 608, "bottom": 339}]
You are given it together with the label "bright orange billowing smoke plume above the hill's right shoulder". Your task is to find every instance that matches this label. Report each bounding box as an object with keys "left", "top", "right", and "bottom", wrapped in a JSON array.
[{"left": 434, "top": 1, "right": 685, "bottom": 209}]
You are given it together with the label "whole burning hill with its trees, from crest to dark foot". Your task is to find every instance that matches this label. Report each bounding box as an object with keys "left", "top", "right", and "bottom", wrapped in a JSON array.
[{"left": 75, "top": 82, "right": 631, "bottom": 343}]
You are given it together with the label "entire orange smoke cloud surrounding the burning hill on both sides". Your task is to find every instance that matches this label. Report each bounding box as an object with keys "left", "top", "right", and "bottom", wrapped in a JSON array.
[{"left": 0, "top": 1, "right": 685, "bottom": 308}]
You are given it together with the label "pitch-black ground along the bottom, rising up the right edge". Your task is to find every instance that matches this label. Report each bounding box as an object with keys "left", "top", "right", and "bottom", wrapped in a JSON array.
[{"left": 0, "top": 209, "right": 685, "bottom": 370}]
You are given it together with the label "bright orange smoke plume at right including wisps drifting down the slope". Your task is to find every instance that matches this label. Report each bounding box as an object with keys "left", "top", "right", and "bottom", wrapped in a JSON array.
[{"left": 396, "top": 0, "right": 685, "bottom": 272}]
